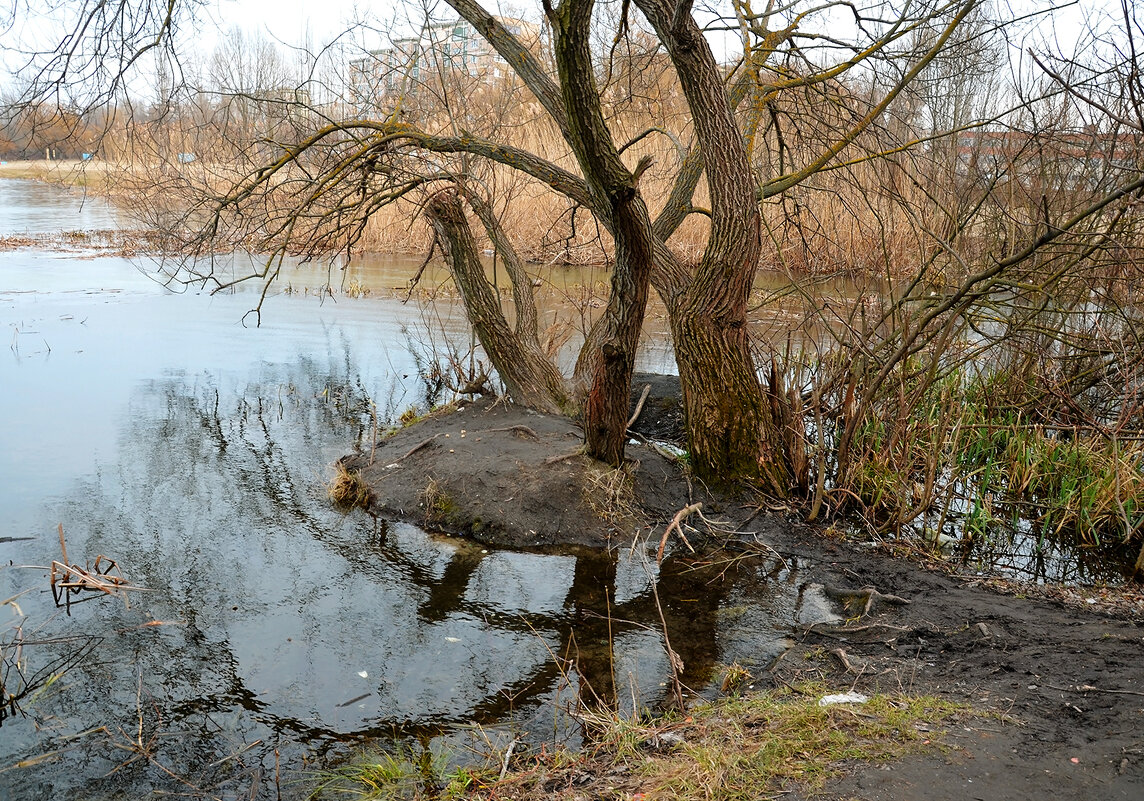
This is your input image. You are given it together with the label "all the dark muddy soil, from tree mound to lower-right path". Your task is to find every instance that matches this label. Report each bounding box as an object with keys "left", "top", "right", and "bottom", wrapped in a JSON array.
[{"left": 347, "top": 382, "right": 1144, "bottom": 801}]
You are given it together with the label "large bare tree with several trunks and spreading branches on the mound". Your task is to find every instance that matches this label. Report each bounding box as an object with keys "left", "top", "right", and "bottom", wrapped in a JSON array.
[{"left": 17, "top": 0, "right": 1144, "bottom": 495}]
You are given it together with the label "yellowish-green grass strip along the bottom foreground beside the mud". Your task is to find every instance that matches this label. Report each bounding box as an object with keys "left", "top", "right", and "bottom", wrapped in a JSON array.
[{"left": 316, "top": 684, "right": 971, "bottom": 801}]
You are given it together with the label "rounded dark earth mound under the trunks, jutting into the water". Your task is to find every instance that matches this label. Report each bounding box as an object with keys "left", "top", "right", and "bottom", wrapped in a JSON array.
[{"left": 332, "top": 376, "right": 712, "bottom": 548}]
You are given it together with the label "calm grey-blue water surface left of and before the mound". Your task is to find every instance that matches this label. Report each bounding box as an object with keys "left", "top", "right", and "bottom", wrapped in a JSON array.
[{"left": 0, "top": 181, "right": 811, "bottom": 800}]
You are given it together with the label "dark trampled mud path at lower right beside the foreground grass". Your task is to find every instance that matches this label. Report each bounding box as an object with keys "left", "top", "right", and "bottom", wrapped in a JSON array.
[{"left": 771, "top": 517, "right": 1144, "bottom": 801}]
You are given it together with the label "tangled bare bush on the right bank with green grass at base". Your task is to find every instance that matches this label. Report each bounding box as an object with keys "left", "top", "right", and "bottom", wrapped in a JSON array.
[{"left": 772, "top": 4, "right": 1144, "bottom": 574}]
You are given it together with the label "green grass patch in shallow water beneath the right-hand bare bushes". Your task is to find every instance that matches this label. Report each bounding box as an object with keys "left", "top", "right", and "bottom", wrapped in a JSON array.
[{"left": 837, "top": 366, "right": 1144, "bottom": 547}]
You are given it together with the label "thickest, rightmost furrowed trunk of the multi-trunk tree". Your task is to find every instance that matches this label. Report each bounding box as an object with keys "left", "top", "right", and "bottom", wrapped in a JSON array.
[{"left": 635, "top": 0, "right": 787, "bottom": 494}]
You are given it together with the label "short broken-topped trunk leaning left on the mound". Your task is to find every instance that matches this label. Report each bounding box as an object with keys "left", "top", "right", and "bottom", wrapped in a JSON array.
[{"left": 426, "top": 190, "right": 569, "bottom": 413}]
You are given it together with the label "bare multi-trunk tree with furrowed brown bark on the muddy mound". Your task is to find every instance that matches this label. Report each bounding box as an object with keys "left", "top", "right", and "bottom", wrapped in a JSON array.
[{"left": 136, "top": 0, "right": 980, "bottom": 494}]
